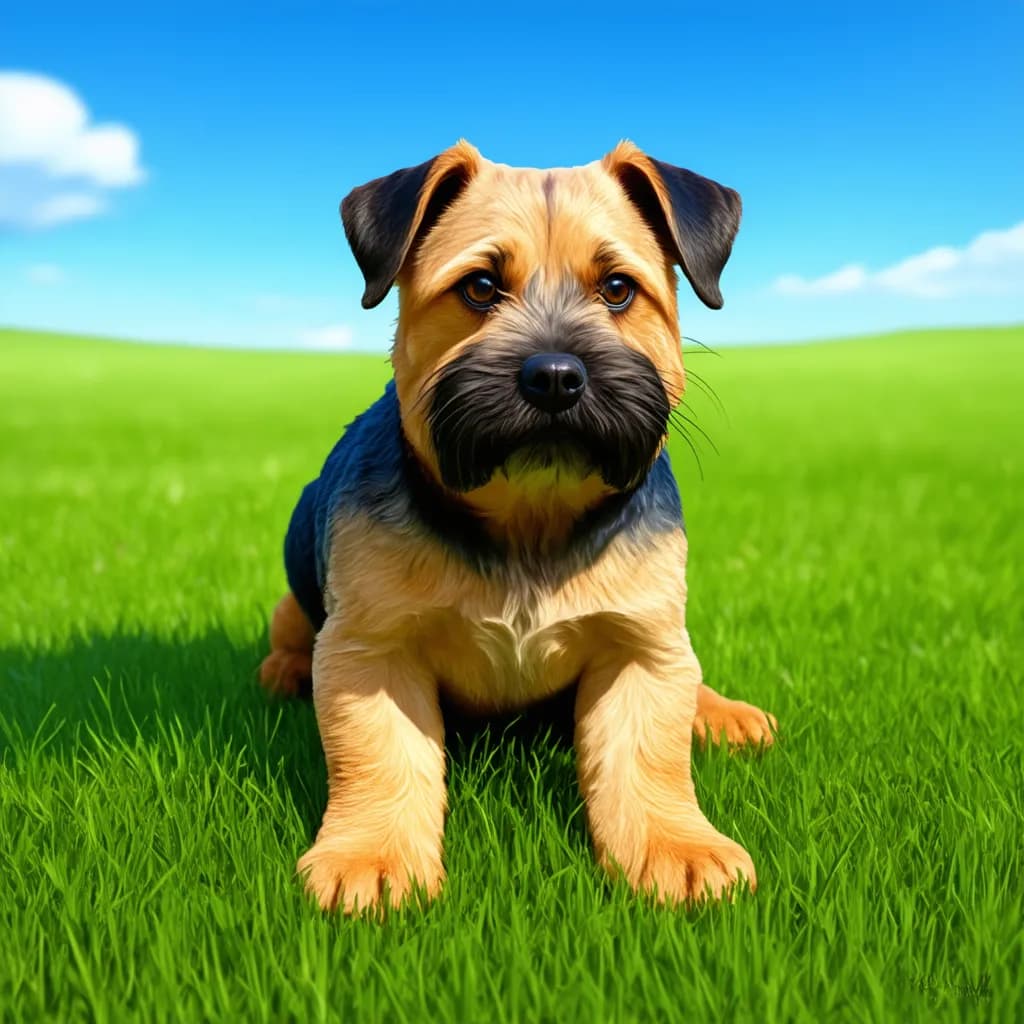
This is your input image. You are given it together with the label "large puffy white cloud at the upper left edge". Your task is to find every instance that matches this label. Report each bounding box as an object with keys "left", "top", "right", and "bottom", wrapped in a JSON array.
[{"left": 0, "top": 72, "right": 145, "bottom": 227}]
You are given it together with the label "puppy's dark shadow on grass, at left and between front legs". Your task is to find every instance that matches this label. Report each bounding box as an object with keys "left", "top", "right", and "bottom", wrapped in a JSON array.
[{"left": 0, "top": 631, "right": 580, "bottom": 839}]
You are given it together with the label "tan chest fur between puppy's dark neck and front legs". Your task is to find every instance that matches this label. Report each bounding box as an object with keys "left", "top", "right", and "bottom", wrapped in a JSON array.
[{"left": 327, "top": 512, "right": 686, "bottom": 712}]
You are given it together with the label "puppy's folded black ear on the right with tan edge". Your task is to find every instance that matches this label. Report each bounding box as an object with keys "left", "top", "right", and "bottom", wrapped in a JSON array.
[{"left": 602, "top": 142, "right": 742, "bottom": 309}]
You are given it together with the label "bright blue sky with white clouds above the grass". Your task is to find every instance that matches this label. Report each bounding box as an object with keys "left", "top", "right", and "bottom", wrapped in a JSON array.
[{"left": 0, "top": 0, "right": 1024, "bottom": 350}]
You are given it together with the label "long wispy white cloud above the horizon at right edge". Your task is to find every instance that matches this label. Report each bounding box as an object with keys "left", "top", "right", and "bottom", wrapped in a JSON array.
[{"left": 772, "top": 221, "right": 1024, "bottom": 299}]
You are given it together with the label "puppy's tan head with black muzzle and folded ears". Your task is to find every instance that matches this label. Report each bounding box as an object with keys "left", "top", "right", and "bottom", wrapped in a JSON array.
[{"left": 341, "top": 142, "right": 740, "bottom": 544}]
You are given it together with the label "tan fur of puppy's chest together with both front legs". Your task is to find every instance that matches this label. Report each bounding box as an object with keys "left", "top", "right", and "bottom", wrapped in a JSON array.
[{"left": 300, "top": 520, "right": 756, "bottom": 910}]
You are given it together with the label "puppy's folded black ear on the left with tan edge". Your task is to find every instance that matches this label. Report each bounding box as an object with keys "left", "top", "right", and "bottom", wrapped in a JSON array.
[{"left": 341, "top": 140, "right": 480, "bottom": 309}]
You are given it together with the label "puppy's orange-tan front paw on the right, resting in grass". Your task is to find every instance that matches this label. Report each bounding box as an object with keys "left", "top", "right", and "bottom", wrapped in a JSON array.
[{"left": 636, "top": 828, "right": 758, "bottom": 904}]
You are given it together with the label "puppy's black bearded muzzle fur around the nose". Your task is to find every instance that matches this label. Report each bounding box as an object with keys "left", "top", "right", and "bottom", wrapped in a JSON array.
[{"left": 428, "top": 336, "right": 669, "bottom": 493}]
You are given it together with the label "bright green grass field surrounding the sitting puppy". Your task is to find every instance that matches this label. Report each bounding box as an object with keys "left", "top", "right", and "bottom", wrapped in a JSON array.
[{"left": 0, "top": 328, "right": 1024, "bottom": 1022}]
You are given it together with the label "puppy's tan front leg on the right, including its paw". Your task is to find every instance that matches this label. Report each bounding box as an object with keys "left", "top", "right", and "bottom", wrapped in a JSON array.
[{"left": 575, "top": 644, "right": 757, "bottom": 902}]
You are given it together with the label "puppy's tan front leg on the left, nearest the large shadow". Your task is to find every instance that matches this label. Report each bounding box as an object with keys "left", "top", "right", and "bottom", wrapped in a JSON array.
[{"left": 298, "top": 620, "right": 446, "bottom": 912}]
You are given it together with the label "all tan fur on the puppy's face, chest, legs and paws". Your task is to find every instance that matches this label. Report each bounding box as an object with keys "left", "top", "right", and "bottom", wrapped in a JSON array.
[{"left": 280, "top": 143, "right": 775, "bottom": 911}]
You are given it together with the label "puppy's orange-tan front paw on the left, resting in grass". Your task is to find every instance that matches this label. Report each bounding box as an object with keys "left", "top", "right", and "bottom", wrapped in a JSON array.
[{"left": 297, "top": 843, "right": 444, "bottom": 914}]
